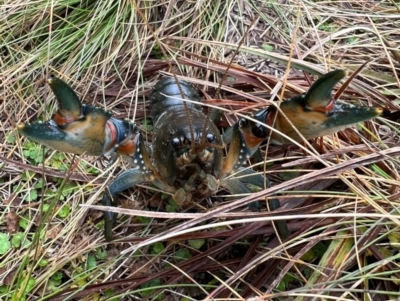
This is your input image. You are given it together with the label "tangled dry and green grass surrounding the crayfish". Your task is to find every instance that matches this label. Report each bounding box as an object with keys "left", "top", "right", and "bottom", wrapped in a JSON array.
[{"left": 0, "top": 0, "right": 400, "bottom": 300}]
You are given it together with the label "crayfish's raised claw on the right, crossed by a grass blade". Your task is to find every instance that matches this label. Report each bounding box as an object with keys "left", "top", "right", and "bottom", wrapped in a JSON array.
[{"left": 264, "top": 70, "right": 383, "bottom": 144}]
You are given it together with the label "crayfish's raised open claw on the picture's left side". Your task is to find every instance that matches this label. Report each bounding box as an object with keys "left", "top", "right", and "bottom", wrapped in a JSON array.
[{"left": 18, "top": 76, "right": 125, "bottom": 156}]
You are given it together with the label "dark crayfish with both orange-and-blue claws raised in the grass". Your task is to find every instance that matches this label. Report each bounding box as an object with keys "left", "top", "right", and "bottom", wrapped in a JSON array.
[{"left": 18, "top": 70, "right": 382, "bottom": 240}]
